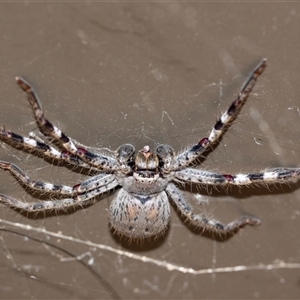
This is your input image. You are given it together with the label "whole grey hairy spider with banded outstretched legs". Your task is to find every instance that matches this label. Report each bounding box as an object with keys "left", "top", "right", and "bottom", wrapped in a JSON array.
[{"left": 0, "top": 59, "right": 300, "bottom": 238}]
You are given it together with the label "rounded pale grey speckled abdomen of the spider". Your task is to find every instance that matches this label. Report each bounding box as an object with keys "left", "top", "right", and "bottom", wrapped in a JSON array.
[{"left": 109, "top": 189, "right": 170, "bottom": 239}]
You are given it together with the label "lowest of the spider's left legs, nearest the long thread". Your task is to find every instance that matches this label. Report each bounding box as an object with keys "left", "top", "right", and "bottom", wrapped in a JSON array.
[{"left": 0, "top": 179, "right": 118, "bottom": 213}]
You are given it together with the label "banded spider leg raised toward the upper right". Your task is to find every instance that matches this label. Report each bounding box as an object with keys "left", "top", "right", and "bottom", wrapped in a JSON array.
[{"left": 172, "top": 58, "right": 267, "bottom": 170}]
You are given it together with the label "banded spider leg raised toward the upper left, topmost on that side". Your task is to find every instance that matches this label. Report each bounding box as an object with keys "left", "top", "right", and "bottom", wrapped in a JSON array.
[{"left": 16, "top": 77, "right": 118, "bottom": 170}]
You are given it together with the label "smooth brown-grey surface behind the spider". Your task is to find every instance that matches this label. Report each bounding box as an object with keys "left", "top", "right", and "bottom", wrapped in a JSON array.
[{"left": 0, "top": 2, "right": 300, "bottom": 299}]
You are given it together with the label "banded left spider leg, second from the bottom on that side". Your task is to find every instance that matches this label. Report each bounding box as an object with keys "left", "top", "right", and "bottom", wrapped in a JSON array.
[{"left": 0, "top": 161, "right": 115, "bottom": 197}]
